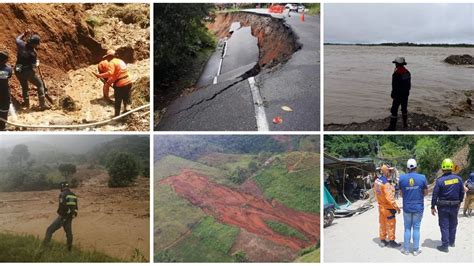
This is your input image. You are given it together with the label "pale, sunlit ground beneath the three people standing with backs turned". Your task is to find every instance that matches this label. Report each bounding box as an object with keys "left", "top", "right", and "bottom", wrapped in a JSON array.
[{"left": 324, "top": 196, "right": 474, "bottom": 263}]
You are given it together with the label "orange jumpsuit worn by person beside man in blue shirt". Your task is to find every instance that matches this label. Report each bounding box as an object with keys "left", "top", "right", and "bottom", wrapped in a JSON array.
[{"left": 374, "top": 176, "right": 400, "bottom": 241}]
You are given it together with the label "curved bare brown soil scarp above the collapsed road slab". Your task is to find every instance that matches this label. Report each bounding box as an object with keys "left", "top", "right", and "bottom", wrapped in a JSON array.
[{"left": 207, "top": 12, "right": 300, "bottom": 67}]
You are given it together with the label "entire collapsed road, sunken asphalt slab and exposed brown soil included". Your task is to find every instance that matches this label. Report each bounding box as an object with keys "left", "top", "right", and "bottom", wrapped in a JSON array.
[{"left": 156, "top": 9, "right": 320, "bottom": 131}]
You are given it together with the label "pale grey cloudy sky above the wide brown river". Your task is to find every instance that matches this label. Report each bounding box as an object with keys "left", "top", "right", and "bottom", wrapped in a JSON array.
[{"left": 323, "top": 3, "right": 474, "bottom": 44}]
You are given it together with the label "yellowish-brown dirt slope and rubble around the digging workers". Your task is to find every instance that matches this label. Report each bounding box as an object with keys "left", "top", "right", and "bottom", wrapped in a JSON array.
[{"left": 0, "top": 4, "right": 150, "bottom": 131}]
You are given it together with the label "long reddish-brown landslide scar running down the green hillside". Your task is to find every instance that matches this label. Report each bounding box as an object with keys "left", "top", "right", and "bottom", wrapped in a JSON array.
[{"left": 160, "top": 170, "right": 320, "bottom": 250}]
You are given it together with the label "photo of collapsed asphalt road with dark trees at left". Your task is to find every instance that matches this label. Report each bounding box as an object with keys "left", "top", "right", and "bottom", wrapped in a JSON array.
[{"left": 154, "top": 3, "right": 320, "bottom": 131}]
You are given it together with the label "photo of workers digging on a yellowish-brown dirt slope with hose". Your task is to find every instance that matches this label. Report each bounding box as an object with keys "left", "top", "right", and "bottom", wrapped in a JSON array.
[{"left": 0, "top": 3, "right": 151, "bottom": 131}]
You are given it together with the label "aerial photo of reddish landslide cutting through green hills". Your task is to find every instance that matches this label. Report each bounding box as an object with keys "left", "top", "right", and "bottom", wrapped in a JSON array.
[{"left": 154, "top": 135, "right": 320, "bottom": 263}]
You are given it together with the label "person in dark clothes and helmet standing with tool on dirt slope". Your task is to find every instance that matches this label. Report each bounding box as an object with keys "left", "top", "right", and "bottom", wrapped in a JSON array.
[{"left": 15, "top": 30, "right": 50, "bottom": 111}]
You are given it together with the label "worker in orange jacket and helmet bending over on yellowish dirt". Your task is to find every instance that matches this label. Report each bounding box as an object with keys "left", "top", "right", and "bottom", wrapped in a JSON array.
[{"left": 95, "top": 50, "right": 133, "bottom": 116}]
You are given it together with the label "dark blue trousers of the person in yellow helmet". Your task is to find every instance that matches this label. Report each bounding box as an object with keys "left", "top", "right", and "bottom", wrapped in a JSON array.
[{"left": 438, "top": 206, "right": 459, "bottom": 247}]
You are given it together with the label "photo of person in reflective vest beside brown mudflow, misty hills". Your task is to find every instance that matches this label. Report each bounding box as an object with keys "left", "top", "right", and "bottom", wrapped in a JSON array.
[{"left": 0, "top": 135, "right": 150, "bottom": 262}]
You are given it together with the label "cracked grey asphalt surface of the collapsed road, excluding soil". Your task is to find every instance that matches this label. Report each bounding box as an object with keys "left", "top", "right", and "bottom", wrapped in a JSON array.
[{"left": 157, "top": 9, "right": 320, "bottom": 131}]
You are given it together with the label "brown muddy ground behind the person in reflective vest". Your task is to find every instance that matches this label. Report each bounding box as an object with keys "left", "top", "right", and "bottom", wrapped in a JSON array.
[{"left": 0, "top": 169, "right": 150, "bottom": 260}]
